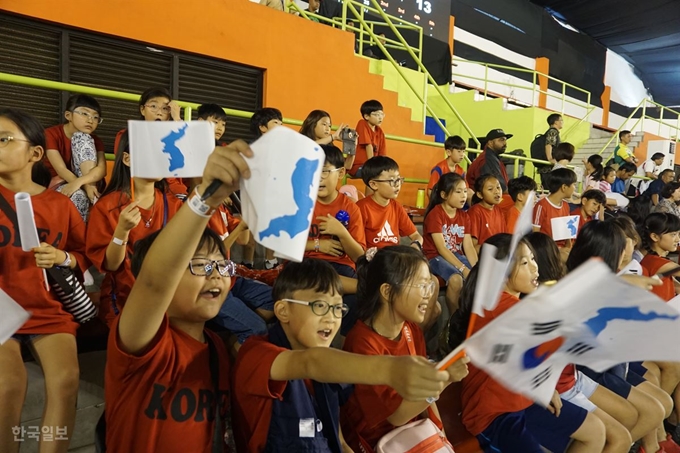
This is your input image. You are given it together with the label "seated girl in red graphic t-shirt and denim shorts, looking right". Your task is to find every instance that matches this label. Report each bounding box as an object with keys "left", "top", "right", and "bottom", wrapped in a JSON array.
[{"left": 423, "top": 173, "right": 477, "bottom": 313}]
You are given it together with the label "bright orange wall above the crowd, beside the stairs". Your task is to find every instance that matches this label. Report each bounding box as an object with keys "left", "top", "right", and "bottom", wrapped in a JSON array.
[{"left": 0, "top": 0, "right": 443, "bottom": 204}]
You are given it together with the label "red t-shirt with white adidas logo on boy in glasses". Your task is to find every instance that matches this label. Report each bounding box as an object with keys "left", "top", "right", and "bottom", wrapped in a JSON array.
[{"left": 357, "top": 197, "right": 417, "bottom": 249}]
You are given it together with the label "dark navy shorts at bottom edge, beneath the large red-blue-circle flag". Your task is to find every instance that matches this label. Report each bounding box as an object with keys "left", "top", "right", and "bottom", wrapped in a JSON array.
[{"left": 477, "top": 400, "right": 588, "bottom": 453}]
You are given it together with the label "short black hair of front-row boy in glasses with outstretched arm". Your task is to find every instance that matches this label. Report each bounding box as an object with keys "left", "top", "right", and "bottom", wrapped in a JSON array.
[{"left": 272, "top": 258, "right": 343, "bottom": 301}]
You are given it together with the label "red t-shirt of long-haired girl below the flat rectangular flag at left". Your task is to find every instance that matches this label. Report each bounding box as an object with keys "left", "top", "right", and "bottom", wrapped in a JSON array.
[{"left": 86, "top": 189, "right": 182, "bottom": 324}]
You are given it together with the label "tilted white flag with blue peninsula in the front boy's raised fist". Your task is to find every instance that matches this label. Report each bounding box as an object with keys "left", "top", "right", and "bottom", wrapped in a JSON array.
[{"left": 241, "top": 127, "right": 326, "bottom": 261}]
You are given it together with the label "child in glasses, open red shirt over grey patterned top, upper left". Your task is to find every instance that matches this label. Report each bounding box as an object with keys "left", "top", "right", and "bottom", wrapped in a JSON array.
[{"left": 43, "top": 94, "right": 106, "bottom": 217}]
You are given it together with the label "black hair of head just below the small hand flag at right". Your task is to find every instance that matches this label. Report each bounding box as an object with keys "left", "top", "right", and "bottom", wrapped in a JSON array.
[{"left": 567, "top": 222, "right": 626, "bottom": 272}]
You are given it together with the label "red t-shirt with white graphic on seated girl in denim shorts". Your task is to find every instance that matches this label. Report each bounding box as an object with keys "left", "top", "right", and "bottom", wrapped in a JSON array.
[{"left": 423, "top": 205, "right": 470, "bottom": 260}]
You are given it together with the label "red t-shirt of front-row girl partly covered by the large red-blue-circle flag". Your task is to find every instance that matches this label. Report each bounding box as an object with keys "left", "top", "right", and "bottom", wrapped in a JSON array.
[{"left": 461, "top": 292, "right": 533, "bottom": 436}]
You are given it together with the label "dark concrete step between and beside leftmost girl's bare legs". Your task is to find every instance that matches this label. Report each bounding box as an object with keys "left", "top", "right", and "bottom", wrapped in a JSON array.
[{"left": 20, "top": 351, "right": 106, "bottom": 453}]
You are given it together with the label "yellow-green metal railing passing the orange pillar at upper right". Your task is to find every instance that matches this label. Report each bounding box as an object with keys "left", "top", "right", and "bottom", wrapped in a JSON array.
[{"left": 453, "top": 58, "right": 595, "bottom": 138}]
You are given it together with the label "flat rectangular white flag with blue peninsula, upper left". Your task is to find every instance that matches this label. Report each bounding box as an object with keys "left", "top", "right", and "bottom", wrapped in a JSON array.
[{"left": 128, "top": 121, "right": 215, "bottom": 179}]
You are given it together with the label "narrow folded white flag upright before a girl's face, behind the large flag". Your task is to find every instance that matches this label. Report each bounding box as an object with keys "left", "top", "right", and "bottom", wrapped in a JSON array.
[{"left": 472, "top": 192, "right": 534, "bottom": 317}]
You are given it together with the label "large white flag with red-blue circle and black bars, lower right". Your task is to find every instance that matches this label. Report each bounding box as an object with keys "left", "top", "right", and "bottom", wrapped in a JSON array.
[{"left": 463, "top": 259, "right": 680, "bottom": 406}]
